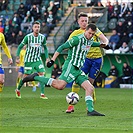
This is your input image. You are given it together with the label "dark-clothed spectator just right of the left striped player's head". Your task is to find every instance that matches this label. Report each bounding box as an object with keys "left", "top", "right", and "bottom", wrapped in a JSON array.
[{"left": 40, "top": 21, "right": 50, "bottom": 38}]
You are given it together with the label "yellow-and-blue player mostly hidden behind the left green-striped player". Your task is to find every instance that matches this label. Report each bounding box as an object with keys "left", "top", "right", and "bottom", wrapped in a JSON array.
[{"left": 16, "top": 45, "right": 36, "bottom": 91}]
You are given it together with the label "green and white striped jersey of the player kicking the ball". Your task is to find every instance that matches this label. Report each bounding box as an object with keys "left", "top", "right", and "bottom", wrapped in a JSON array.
[{"left": 57, "top": 34, "right": 100, "bottom": 68}]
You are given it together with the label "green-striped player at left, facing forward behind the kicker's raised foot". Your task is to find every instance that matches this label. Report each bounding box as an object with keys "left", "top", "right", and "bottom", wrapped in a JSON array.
[{"left": 16, "top": 21, "right": 49, "bottom": 99}]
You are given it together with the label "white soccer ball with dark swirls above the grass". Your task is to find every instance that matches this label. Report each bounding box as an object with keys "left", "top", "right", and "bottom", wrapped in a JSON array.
[{"left": 66, "top": 92, "right": 79, "bottom": 105}]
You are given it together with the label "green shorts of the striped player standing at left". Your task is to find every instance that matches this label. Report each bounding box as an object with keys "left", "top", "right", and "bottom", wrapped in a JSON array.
[{"left": 24, "top": 60, "right": 45, "bottom": 74}]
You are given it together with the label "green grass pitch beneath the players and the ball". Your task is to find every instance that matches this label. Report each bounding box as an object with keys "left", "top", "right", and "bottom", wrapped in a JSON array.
[{"left": 0, "top": 87, "right": 133, "bottom": 133}]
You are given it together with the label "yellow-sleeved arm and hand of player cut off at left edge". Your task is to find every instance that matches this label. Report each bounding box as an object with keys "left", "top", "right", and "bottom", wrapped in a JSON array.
[{"left": 1, "top": 35, "right": 13, "bottom": 64}]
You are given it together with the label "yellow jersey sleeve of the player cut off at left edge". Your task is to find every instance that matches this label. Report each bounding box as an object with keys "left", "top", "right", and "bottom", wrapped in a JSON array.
[{"left": 1, "top": 35, "right": 12, "bottom": 58}]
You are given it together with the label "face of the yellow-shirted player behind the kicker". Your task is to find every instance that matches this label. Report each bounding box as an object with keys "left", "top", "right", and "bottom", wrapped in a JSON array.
[{"left": 78, "top": 17, "right": 88, "bottom": 30}]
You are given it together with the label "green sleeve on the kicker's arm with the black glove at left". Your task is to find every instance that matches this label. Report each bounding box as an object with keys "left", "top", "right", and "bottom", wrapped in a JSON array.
[{"left": 56, "top": 36, "right": 79, "bottom": 53}]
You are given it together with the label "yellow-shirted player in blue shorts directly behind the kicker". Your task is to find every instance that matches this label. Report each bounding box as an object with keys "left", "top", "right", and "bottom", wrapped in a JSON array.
[{"left": 66, "top": 12, "right": 108, "bottom": 113}]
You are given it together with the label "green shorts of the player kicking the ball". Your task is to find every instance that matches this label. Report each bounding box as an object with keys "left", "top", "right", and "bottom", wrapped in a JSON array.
[{"left": 59, "top": 61, "right": 88, "bottom": 85}]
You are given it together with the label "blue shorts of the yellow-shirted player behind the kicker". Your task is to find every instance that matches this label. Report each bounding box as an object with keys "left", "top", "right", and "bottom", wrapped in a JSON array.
[{"left": 81, "top": 57, "right": 103, "bottom": 79}]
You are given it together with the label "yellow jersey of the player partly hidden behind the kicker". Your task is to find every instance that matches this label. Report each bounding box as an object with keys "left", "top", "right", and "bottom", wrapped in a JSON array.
[{"left": 68, "top": 28, "right": 103, "bottom": 59}]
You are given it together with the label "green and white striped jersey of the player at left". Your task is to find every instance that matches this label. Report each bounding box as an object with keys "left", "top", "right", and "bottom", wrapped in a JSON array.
[{"left": 17, "top": 33, "right": 47, "bottom": 62}]
